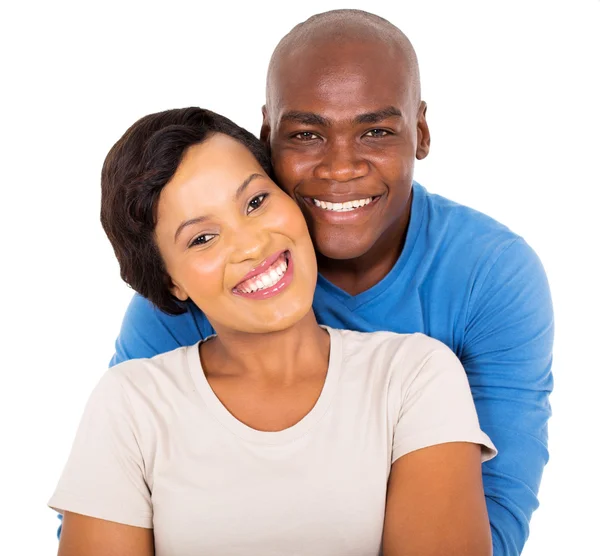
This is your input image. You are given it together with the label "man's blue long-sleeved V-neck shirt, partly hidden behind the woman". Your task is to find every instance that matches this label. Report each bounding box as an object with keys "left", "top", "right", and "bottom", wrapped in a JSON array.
[{"left": 111, "top": 183, "right": 554, "bottom": 556}]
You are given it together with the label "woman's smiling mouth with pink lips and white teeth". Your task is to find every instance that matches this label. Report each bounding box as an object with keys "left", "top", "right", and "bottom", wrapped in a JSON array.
[{"left": 233, "top": 251, "right": 294, "bottom": 300}]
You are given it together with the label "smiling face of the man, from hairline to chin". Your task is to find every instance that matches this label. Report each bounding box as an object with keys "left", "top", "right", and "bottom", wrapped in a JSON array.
[{"left": 261, "top": 41, "right": 429, "bottom": 259}]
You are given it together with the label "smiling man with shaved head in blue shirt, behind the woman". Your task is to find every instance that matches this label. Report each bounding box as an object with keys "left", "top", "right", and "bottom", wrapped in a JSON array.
[{"left": 106, "top": 10, "right": 553, "bottom": 556}]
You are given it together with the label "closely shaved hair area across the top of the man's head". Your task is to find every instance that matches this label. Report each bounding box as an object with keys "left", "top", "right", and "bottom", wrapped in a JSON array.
[{"left": 266, "top": 10, "right": 421, "bottom": 110}]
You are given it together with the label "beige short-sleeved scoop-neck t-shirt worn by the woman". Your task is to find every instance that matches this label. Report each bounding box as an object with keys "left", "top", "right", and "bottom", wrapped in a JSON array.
[{"left": 49, "top": 328, "right": 495, "bottom": 556}]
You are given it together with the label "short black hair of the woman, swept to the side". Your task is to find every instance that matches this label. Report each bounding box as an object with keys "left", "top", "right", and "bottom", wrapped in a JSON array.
[{"left": 100, "top": 107, "right": 273, "bottom": 315}]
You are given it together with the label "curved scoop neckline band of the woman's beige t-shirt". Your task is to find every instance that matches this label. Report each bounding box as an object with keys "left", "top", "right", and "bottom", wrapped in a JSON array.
[{"left": 186, "top": 326, "right": 343, "bottom": 444}]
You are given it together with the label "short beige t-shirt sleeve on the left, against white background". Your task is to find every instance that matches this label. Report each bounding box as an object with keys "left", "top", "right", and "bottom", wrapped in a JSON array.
[{"left": 48, "top": 369, "right": 152, "bottom": 529}]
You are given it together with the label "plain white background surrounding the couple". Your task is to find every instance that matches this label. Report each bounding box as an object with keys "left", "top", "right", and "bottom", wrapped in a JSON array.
[{"left": 0, "top": 0, "right": 600, "bottom": 556}]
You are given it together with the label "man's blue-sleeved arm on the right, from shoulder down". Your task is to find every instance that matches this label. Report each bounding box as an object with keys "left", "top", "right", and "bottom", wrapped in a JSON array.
[{"left": 460, "top": 238, "right": 554, "bottom": 556}]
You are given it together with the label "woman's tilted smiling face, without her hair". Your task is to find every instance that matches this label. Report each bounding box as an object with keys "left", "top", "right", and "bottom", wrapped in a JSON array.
[{"left": 155, "top": 133, "right": 317, "bottom": 334}]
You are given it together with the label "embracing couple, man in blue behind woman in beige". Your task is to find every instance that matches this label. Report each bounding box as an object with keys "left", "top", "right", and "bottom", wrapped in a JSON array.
[{"left": 50, "top": 10, "right": 553, "bottom": 556}]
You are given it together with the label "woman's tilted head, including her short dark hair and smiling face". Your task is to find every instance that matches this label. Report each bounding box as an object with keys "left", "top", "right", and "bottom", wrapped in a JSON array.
[{"left": 101, "top": 108, "right": 317, "bottom": 332}]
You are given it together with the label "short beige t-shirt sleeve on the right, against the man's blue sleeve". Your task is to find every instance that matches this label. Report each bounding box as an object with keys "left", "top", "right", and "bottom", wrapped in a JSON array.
[{"left": 392, "top": 335, "right": 496, "bottom": 463}]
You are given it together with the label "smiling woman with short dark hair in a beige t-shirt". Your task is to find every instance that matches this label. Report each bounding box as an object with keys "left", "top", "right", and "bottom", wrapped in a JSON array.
[{"left": 50, "top": 108, "right": 494, "bottom": 556}]
